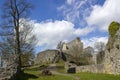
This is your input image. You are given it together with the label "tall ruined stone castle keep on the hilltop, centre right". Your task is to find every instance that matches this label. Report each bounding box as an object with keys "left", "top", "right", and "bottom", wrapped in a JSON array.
[{"left": 62, "top": 37, "right": 96, "bottom": 64}]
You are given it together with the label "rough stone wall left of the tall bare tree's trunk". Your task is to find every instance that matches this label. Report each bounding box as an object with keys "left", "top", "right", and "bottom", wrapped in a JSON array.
[{"left": 0, "top": 54, "right": 18, "bottom": 80}]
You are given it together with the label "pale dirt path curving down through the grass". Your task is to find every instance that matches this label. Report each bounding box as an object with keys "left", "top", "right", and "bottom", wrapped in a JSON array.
[{"left": 47, "top": 64, "right": 80, "bottom": 80}]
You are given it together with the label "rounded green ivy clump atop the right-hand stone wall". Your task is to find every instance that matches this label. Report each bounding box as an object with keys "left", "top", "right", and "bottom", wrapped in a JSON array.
[{"left": 108, "top": 21, "right": 120, "bottom": 37}]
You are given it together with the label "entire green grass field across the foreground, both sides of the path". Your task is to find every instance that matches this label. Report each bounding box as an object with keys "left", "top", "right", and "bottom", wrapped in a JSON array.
[{"left": 18, "top": 66, "right": 120, "bottom": 80}]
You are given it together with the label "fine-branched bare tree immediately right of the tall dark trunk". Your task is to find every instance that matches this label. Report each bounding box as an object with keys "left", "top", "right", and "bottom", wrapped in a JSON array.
[{"left": 20, "top": 19, "right": 37, "bottom": 66}]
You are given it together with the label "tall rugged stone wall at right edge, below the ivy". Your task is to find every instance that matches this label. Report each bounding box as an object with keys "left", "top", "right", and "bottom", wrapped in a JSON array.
[{"left": 103, "top": 23, "right": 120, "bottom": 74}]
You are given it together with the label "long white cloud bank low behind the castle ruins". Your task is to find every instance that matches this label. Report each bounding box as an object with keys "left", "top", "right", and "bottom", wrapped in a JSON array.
[{"left": 30, "top": 20, "right": 92, "bottom": 50}]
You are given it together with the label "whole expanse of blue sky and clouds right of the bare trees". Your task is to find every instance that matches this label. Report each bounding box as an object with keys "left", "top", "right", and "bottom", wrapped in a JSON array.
[{"left": 0, "top": 0, "right": 120, "bottom": 52}]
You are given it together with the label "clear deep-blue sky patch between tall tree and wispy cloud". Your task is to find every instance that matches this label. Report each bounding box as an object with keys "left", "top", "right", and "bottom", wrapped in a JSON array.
[{"left": 31, "top": 0, "right": 65, "bottom": 22}]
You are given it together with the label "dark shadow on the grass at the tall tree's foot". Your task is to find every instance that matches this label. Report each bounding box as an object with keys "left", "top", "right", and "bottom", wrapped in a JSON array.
[{"left": 17, "top": 73, "right": 38, "bottom": 80}]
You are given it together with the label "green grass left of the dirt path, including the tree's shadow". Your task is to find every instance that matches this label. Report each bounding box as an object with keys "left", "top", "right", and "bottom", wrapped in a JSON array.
[{"left": 18, "top": 66, "right": 74, "bottom": 80}]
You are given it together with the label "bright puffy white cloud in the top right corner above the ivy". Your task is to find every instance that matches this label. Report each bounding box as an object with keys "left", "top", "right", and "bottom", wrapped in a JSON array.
[{"left": 86, "top": 0, "right": 120, "bottom": 31}]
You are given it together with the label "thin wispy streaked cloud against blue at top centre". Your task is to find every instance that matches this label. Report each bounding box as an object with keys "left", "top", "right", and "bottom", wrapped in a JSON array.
[{"left": 57, "top": 0, "right": 87, "bottom": 23}]
